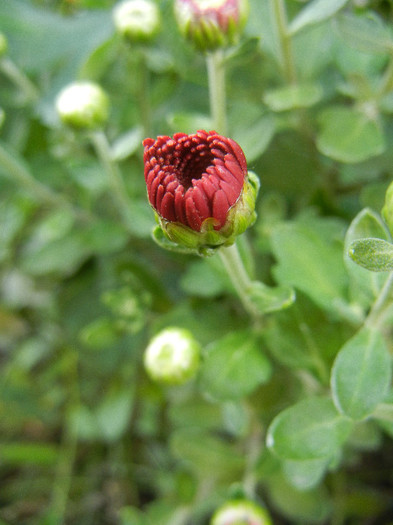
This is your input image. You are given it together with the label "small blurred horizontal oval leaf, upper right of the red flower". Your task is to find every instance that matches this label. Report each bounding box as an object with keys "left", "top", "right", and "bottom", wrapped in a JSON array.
[{"left": 263, "top": 84, "right": 323, "bottom": 111}]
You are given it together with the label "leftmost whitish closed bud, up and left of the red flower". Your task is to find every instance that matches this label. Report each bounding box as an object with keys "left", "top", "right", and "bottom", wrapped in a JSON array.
[{"left": 56, "top": 82, "right": 109, "bottom": 129}]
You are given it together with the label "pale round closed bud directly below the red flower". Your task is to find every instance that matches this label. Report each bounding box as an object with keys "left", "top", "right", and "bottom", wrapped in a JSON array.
[{"left": 144, "top": 328, "right": 201, "bottom": 385}]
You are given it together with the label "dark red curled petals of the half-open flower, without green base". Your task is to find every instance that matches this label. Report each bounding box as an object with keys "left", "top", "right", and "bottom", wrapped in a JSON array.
[{"left": 143, "top": 130, "right": 247, "bottom": 232}]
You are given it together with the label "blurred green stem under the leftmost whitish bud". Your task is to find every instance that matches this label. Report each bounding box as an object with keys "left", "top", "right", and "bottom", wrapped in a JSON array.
[{"left": 91, "top": 131, "right": 131, "bottom": 227}]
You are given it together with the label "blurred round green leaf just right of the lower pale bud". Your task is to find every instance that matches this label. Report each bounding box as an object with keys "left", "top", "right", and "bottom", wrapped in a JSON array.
[{"left": 200, "top": 331, "right": 272, "bottom": 400}]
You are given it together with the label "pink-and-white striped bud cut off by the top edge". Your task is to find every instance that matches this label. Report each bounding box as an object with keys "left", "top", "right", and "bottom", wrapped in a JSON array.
[{"left": 175, "top": 0, "right": 248, "bottom": 51}]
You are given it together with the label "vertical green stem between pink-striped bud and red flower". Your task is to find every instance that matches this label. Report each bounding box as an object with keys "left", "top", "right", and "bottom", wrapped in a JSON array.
[{"left": 206, "top": 49, "right": 227, "bottom": 135}]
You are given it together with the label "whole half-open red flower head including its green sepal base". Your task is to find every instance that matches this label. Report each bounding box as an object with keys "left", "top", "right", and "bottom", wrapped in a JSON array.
[{"left": 143, "top": 130, "right": 259, "bottom": 252}]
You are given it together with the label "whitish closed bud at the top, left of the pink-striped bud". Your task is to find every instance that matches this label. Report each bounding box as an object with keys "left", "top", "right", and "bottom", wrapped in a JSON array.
[{"left": 113, "top": 0, "right": 161, "bottom": 42}]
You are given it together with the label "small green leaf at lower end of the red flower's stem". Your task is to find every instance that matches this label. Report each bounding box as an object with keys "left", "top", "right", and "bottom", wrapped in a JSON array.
[{"left": 247, "top": 281, "right": 295, "bottom": 314}]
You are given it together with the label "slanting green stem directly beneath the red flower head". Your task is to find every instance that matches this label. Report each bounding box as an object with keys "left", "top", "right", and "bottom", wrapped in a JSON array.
[{"left": 218, "top": 244, "right": 259, "bottom": 317}]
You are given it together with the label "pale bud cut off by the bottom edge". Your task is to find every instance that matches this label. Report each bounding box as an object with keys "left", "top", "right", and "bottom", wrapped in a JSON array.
[{"left": 210, "top": 499, "right": 272, "bottom": 525}]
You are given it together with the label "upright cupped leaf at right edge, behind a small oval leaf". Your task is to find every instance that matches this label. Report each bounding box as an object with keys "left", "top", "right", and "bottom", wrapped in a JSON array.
[{"left": 344, "top": 208, "right": 388, "bottom": 309}]
